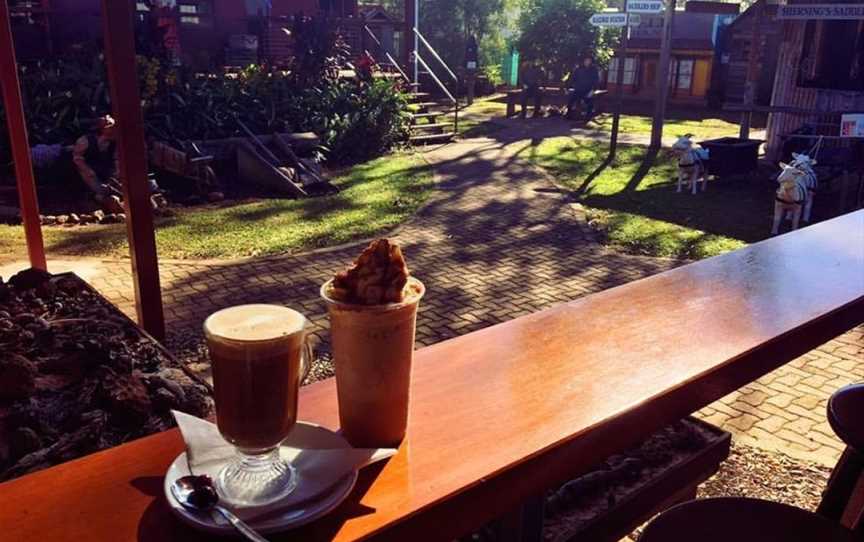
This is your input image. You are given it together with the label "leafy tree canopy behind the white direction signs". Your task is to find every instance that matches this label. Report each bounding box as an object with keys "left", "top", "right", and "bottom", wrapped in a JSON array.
[{"left": 517, "top": 0, "right": 619, "bottom": 80}]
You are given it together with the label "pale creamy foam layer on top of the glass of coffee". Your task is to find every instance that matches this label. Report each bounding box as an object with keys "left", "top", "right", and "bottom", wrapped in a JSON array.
[{"left": 204, "top": 304, "right": 306, "bottom": 342}]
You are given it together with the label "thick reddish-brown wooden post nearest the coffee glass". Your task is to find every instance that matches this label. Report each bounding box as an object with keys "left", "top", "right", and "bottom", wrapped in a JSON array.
[{"left": 102, "top": 0, "right": 165, "bottom": 340}]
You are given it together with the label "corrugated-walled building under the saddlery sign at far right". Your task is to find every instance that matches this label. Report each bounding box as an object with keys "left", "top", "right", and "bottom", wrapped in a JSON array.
[{"left": 768, "top": 0, "right": 864, "bottom": 158}]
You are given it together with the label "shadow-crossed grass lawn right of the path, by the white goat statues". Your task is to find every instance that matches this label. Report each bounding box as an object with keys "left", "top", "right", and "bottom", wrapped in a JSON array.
[{"left": 523, "top": 137, "right": 773, "bottom": 259}]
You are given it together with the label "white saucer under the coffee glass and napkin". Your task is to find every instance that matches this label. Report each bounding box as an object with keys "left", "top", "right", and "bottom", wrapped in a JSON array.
[{"left": 163, "top": 422, "right": 358, "bottom": 535}]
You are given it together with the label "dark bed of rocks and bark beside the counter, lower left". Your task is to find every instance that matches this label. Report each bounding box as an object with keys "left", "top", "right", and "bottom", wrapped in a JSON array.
[{"left": 0, "top": 269, "right": 212, "bottom": 481}]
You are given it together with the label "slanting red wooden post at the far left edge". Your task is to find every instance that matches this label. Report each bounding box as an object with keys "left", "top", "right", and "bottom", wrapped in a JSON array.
[{"left": 0, "top": 0, "right": 47, "bottom": 270}]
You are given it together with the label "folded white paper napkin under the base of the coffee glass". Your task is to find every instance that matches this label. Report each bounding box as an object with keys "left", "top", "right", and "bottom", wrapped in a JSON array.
[{"left": 171, "top": 410, "right": 397, "bottom": 521}]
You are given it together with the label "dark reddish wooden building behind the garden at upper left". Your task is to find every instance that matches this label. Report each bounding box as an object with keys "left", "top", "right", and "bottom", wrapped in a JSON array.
[{"left": 9, "top": 0, "right": 388, "bottom": 69}]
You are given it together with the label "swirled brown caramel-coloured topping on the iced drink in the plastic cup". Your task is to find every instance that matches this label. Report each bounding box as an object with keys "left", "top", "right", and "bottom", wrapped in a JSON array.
[{"left": 328, "top": 239, "right": 409, "bottom": 305}]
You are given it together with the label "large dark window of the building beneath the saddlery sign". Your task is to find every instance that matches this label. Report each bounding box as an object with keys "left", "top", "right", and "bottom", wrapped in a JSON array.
[{"left": 798, "top": 20, "right": 864, "bottom": 90}]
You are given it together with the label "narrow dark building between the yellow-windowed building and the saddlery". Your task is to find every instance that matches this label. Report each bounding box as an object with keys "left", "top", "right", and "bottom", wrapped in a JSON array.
[{"left": 712, "top": 0, "right": 782, "bottom": 106}]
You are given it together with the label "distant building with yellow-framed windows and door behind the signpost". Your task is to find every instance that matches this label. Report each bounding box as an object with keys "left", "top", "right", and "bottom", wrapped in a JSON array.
[{"left": 603, "top": 2, "right": 739, "bottom": 104}]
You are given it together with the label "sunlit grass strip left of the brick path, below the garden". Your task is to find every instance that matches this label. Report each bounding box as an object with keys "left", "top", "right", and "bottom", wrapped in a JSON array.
[{"left": 0, "top": 154, "right": 433, "bottom": 259}]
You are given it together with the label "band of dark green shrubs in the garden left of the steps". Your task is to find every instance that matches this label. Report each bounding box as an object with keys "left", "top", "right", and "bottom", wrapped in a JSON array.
[{"left": 0, "top": 18, "right": 408, "bottom": 168}]
